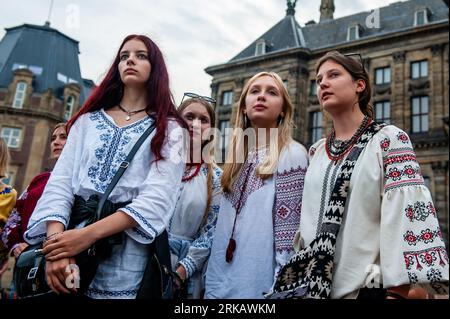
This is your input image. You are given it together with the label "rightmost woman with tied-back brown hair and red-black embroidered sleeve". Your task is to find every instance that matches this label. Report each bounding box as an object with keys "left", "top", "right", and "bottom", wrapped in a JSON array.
[{"left": 296, "top": 51, "right": 449, "bottom": 298}]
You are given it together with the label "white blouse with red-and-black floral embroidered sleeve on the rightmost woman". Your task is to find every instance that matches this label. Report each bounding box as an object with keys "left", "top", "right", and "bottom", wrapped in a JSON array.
[{"left": 297, "top": 125, "right": 449, "bottom": 298}]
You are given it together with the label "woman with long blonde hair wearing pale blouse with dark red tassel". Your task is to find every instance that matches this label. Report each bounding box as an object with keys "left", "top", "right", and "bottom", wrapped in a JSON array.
[{"left": 205, "top": 72, "right": 307, "bottom": 298}]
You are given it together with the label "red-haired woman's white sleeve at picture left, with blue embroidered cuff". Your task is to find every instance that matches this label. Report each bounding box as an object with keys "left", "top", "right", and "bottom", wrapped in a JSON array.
[{"left": 24, "top": 117, "right": 84, "bottom": 244}]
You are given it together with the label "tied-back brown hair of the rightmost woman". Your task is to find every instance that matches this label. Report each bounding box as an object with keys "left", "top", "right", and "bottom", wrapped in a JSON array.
[{"left": 316, "top": 51, "right": 373, "bottom": 118}]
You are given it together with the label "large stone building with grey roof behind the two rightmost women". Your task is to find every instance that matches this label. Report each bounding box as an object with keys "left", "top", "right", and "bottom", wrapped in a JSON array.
[{"left": 205, "top": 0, "right": 449, "bottom": 247}]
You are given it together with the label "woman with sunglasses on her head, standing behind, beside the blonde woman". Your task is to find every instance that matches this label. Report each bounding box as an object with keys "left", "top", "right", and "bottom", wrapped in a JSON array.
[{"left": 169, "top": 95, "right": 222, "bottom": 298}]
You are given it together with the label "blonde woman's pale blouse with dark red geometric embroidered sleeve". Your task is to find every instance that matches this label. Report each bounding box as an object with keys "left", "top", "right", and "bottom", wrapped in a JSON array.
[{"left": 205, "top": 142, "right": 308, "bottom": 299}]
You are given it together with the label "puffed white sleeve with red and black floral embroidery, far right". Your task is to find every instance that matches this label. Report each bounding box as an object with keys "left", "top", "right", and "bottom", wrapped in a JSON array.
[{"left": 380, "top": 126, "right": 449, "bottom": 294}]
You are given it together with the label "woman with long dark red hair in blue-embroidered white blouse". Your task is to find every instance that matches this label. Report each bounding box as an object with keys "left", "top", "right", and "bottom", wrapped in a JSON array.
[{"left": 25, "top": 35, "right": 184, "bottom": 298}]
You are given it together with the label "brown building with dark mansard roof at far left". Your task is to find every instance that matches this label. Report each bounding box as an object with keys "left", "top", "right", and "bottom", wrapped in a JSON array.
[{"left": 0, "top": 23, "right": 94, "bottom": 192}]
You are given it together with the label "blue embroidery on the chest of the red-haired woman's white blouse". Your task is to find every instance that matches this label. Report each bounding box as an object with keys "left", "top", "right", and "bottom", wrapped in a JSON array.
[{"left": 88, "top": 111, "right": 152, "bottom": 193}]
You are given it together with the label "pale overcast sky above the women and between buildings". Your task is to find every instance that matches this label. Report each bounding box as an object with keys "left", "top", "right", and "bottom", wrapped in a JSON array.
[{"left": 0, "top": 0, "right": 397, "bottom": 103}]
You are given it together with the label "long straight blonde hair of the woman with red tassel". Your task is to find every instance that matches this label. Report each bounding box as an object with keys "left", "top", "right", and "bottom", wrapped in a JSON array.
[{"left": 221, "top": 72, "right": 294, "bottom": 193}]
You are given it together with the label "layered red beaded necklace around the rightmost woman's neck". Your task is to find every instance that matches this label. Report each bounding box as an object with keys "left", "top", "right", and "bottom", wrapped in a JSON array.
[{"left": 325, "top": 115, "right": 373, "bottom": 163}]
